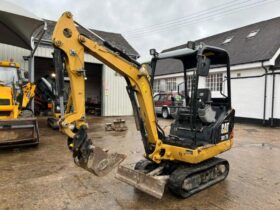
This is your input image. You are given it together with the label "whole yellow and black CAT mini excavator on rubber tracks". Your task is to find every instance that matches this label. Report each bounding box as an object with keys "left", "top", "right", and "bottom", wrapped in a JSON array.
[{"left": 52, "top": 12, "right": 234, "bottom": 198}]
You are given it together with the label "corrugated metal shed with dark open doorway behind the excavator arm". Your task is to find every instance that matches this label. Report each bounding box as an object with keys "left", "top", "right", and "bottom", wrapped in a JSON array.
[{"left": 0, "top": 20, "right": 139, "bottom": 116}]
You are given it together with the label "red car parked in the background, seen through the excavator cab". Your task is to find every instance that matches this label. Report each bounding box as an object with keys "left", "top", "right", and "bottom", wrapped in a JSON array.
[{"left": 154, "top": 92, "right": 183, "bottom": 119}]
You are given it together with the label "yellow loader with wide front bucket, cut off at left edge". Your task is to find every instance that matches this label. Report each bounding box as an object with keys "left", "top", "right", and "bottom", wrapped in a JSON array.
[{"left": 0, "top": 61, "right": 39, "bottom": 148}]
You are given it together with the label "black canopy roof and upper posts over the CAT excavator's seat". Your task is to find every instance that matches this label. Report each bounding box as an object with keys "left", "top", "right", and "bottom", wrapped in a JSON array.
[{"left": 151, "top": 44, "right": 231, "bottom": 103}]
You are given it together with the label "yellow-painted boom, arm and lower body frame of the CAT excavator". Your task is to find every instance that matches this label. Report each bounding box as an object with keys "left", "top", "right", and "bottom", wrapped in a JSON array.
[{"left": 52, "top": 12, "right": 233, "bottom": 163}]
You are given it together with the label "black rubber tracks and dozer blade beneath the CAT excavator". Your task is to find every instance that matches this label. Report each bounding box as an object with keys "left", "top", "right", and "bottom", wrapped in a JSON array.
[{"left": 116, "top": 157, "right": 229, "bottom": 198}]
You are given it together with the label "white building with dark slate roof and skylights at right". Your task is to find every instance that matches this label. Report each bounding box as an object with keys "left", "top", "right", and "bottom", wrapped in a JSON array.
[{"left": 154, "top": 17, "right": 280, "bottom": 126}]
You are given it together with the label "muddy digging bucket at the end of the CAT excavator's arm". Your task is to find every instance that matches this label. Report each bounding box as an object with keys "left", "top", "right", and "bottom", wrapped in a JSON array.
[{"left": 87, "top": 147, "right": 126, "bottom": 176}]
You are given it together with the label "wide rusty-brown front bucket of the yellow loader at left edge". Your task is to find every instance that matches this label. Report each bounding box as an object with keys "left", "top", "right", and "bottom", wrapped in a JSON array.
[{"left": 0, "top": 118, "right": 39, "bottom": 148}]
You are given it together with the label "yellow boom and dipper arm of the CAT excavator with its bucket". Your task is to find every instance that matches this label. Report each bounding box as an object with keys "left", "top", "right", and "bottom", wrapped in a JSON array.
[{"left": 52, "top": 12, "right": 161, "bottom": 175}]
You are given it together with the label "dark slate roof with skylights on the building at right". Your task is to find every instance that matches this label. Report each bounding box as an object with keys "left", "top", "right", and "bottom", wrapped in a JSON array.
[{"left": 157, "top": 17, "right": 280, "bottom": 75}]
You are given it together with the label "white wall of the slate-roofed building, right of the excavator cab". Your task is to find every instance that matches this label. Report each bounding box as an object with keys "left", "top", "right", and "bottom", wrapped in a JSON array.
[{"left": 231, "top": 68, "right": 280, "bottom": 120}]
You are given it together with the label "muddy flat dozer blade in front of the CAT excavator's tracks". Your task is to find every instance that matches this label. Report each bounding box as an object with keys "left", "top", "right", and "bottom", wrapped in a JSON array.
[{"left": 116, "top": 165, "right": 167, "bottom": 199}]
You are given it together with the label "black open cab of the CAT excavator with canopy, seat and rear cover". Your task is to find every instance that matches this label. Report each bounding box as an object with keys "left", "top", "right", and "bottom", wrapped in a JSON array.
[{"left": 151, "top": 44, "right": 234, "bottom": 148}]
